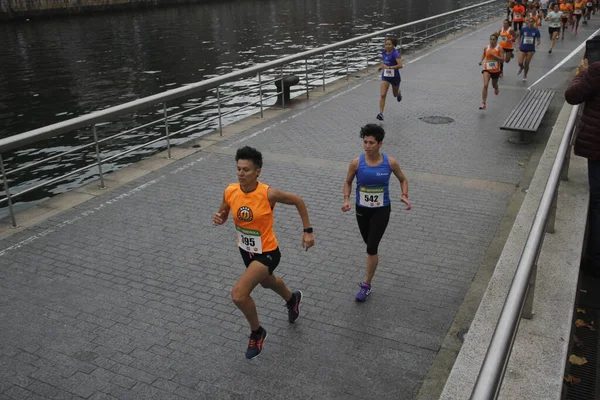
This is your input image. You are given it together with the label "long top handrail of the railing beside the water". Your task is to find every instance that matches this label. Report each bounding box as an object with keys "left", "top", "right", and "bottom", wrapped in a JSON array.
[{"left": 0, "top": 0, "right": 500, "bottom": 153}]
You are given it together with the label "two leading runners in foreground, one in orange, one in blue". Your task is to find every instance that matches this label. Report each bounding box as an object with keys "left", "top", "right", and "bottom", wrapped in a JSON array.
[{"left": 213, "top": 124, "right": 411, "bottom": 359}]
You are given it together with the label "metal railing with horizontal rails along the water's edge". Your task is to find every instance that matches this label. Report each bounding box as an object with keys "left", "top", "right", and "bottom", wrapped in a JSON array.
[{"left": 0, "top": 0, "right": 505, "bottom": 227}]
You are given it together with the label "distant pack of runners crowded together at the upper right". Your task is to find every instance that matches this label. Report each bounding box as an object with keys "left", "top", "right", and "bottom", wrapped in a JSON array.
[{"left": 479, "top": 0, "right": 598, "bottom": 110}]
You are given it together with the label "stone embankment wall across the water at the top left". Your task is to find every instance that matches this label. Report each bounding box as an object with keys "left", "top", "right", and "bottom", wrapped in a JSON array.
[{"left": 0, "top": 0, "right": 206, "bottom": 20}]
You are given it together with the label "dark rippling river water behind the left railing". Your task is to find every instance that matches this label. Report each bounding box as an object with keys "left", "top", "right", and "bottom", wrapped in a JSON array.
[{"left": 0, "top": 0, "right": 477, "bottom": 209}]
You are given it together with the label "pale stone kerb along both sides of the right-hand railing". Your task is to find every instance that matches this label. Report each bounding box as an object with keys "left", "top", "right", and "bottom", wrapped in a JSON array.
[{"left": 440, "top": 104, "right": 588, "bottom": 400}]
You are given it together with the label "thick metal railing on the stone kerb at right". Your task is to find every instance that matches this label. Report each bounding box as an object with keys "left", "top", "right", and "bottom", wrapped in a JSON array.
[{"left": 471, "top": 106, "right": 580, "bottom": 400}]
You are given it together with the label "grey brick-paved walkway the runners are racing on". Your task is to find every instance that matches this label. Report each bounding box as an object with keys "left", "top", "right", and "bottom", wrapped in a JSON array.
[{"left": 0, "top": 15, "right": 598, "bottom": 399}]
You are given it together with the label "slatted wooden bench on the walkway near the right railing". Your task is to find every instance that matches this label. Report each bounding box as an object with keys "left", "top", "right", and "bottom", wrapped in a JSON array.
[{"left": 500, "top": 89, "right": 554, "bottom": 144}]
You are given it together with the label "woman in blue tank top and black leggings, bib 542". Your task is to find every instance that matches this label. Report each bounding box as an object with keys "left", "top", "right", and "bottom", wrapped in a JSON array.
[{"left": 342, "top": 124, "right": 411, "bottom": 301}]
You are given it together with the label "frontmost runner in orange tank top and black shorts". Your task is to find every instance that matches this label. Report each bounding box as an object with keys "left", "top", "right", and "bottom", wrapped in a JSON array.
[{"left": 213, "top": 146, "right": 315, "bottom": 359}]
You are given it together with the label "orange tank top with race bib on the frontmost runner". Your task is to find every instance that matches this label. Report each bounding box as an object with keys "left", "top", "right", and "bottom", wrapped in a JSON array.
[{"left": 225, "top": 182, "right": 278, "bottom": 254}]
